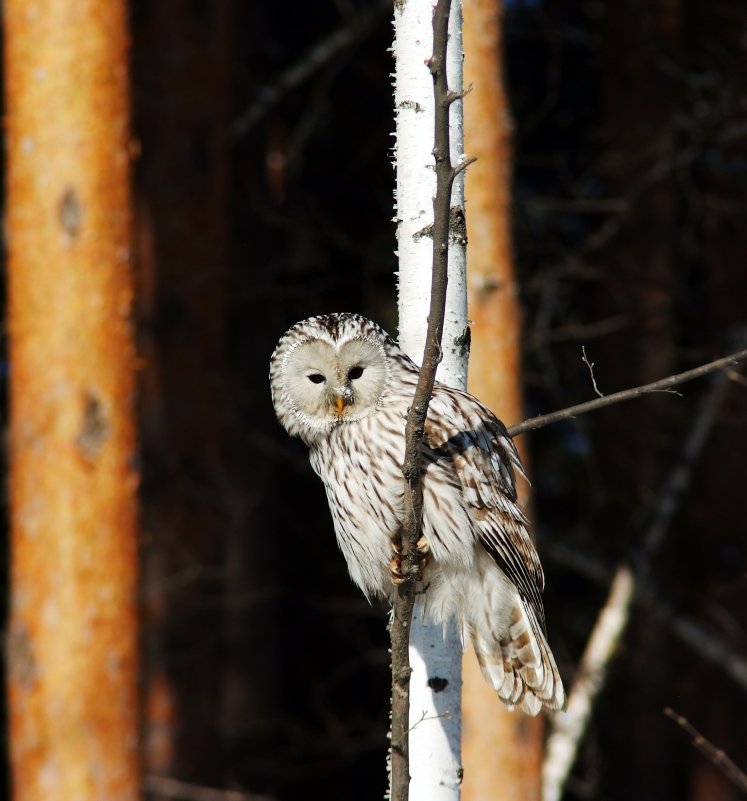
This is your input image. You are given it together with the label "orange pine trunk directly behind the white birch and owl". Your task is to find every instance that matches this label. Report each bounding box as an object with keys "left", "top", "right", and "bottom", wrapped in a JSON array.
[{"left": 462, "top": 0, "right": 543, "bottom": 801}]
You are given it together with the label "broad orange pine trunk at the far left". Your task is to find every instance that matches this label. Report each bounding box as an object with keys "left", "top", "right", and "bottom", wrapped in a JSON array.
[{"left": 3, "top": 0, "right": 140, "bottom": 801}]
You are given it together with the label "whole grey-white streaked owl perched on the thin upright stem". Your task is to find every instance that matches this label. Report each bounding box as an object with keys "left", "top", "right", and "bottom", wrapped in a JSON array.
[{"left": 270, "top": 314, "right": 564, "bottom": 715}]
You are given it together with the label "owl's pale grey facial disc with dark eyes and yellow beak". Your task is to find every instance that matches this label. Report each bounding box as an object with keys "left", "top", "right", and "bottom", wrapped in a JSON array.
[{"left": 286, "top": 339, "right": 388, "bottom": 427}]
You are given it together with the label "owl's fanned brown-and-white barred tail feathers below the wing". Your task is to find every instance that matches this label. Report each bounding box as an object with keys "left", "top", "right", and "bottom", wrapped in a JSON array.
[{"left": 465, "top": 570, "right": 565, "bottom": 715}]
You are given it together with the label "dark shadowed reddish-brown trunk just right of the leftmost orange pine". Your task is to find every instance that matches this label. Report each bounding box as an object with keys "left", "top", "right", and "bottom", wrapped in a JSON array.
[{"left": 133, "top": 0, "right": 231, "bottom": 784}]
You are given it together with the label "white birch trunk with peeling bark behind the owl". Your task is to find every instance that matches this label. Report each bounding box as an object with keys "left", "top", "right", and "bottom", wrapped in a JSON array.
[{"left": 394, "top": 0, "right": 467, "bottom": 801}]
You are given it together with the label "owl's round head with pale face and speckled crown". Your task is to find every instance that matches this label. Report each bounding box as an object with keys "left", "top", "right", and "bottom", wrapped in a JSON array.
[{"left": 270, "top": 314, "right": 396, "bottom": 443}]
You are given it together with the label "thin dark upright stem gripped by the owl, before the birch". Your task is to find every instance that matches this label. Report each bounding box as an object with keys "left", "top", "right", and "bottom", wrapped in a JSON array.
[{"left": 389, "top": 0, "right": 459, "bottom": 801}]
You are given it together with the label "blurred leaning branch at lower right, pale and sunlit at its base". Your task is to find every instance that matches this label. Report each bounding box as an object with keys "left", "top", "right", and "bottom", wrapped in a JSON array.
[{"left": 542, "top": 366, "right": 747, "bottom": 801}]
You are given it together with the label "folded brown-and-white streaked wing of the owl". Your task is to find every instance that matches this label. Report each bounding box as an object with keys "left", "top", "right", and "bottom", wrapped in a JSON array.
[{"left": 424, "top": 384, "right": 545, "bottom": 629}]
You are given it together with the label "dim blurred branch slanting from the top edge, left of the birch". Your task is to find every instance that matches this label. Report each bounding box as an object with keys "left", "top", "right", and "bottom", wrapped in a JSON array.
[{"left": 231, "top": 0, "right": 392, "bottom": 139}]
